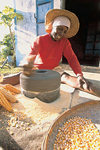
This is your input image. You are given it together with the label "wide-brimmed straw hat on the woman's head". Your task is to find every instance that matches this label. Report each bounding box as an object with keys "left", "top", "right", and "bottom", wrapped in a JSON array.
[{"left": 45, "top": 9, "right": 79, "bottom": 38}]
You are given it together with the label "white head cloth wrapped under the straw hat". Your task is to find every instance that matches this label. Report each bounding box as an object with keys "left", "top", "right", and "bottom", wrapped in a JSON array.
[{"left": 52, "top": 16, "right": 70, "bottom": 28}]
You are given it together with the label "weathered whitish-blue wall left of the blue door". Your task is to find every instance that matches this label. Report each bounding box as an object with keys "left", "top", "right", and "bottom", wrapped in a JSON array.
[{"left": 14, "top": 0, "right": 36, "bottom": 66}]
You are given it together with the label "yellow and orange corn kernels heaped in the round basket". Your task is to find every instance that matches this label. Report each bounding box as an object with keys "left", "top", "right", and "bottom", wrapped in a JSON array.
[{"left": 54, "top": 117, "right": 100, "bottom": 150}]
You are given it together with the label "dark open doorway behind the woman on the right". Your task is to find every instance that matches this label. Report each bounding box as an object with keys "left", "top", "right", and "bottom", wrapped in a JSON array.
[{"left": 63, "top": 0, "right": 100, "bottom": 66}]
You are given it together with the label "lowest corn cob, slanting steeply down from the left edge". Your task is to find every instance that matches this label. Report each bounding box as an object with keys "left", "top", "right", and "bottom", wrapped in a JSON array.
[{"left": 0, "top": 92, "right": 13, "bottom": 112}]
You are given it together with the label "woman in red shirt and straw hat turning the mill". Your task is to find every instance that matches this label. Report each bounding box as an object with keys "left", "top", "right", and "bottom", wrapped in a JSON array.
[{"left": 22, "top": 9, "right": 88, "bottom": 88}]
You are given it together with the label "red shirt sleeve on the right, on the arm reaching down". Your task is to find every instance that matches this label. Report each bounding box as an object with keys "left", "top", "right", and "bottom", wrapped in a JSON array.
[{"left": 63, "top": 40, "right": 83, "bottom": 76}]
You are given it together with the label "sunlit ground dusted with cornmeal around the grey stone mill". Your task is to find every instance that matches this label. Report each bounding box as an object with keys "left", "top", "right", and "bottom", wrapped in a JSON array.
[{"left": 0, "top": 65, "right": 100, "bottom": 150}]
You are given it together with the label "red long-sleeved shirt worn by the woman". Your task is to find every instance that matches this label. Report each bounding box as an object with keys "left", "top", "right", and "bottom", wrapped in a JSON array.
[{"left": 30, "top": 34, "right": 82, "bottom": 75}]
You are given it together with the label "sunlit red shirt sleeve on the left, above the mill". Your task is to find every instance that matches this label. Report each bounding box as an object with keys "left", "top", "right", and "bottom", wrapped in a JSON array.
[{"left": 29, "top": 37, "right": 39, "bottom": 55}]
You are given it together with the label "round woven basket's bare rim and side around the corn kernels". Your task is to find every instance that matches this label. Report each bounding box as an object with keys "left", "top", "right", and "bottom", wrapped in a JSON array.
[{"left": 41, "top": 101, "right": 100, "bottom": 150}]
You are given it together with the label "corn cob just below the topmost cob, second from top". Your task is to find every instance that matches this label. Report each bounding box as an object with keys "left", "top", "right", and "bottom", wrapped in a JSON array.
[{"left": 0, "top": 88, "right": 17, "bottom": 103}]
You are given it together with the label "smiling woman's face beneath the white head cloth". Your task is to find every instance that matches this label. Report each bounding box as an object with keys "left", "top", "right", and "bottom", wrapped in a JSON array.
[{"left": 51, "top": 26, "right": 68, "bottom": 41}]
